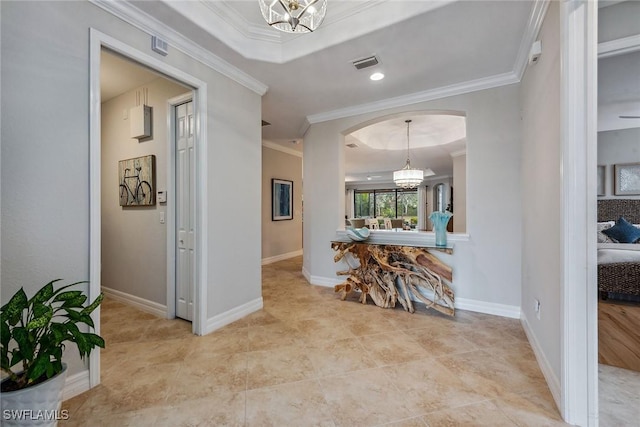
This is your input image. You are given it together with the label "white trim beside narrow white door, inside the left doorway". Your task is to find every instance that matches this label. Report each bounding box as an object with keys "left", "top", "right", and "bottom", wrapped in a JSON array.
[{"left": 166, "top": 92, "right": 198, "bottom": 319}]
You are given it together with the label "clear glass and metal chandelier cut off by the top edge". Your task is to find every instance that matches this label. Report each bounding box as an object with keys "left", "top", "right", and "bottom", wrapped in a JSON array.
[{"left": 258, "top": 0, "right": 327, "bottom": 33}]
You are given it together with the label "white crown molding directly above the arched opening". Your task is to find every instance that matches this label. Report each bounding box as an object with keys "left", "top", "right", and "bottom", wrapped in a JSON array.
[{"left": 307, "top": 71, "right": 520, "bottom": 124}]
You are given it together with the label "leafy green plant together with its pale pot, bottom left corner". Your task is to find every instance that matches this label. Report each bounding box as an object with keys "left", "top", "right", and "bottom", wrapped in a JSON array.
[{"left": 0, "top": 279, "right": 104, "bottom": 425}]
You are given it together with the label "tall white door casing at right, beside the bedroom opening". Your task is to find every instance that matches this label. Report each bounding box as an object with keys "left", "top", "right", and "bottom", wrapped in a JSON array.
[{"left": 556, "top": 0, "right": 598, "bottom": 427}]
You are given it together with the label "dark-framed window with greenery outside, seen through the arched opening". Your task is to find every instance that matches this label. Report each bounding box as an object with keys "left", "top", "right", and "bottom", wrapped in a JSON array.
[{"left": 353, "top": 188, "right": 418, "bottom": 226}]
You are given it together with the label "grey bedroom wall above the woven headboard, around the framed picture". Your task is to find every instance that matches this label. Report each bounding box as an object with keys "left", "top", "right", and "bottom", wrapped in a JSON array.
[{"left": 598, "top": 128, "right": 640, "bottom": 199}]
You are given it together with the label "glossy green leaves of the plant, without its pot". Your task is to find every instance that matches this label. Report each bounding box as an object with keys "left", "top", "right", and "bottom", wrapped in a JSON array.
[{"left": 0, "top": 279, "right": 104, "bottom": 391}]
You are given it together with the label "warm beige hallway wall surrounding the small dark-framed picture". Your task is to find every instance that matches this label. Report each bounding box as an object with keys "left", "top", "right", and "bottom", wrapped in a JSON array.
[{"left": 262, "top": 146, "right": 302, "bottom": 263}]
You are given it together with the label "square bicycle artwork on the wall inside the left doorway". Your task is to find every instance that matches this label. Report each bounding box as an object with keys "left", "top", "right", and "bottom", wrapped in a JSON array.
[{"left": 118, "top": 155, "right": 156, "bottom": 206}]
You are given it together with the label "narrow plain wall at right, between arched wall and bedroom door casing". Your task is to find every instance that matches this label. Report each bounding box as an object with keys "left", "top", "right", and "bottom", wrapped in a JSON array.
[{"left": 520, "top": 2, "right": 562, "bottom": 391}]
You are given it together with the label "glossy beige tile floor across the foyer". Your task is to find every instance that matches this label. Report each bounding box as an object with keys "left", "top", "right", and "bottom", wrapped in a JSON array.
[{"left": 61, "top": 258, "right": 564, "bottom": 427}]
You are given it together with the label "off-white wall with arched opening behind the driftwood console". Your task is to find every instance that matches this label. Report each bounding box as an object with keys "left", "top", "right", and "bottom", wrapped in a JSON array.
[{"left": 304, "top": 85, "right": 521, "bottom": 315}]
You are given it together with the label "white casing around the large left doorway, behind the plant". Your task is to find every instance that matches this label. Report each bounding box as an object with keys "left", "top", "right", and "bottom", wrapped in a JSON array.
[{"left": 89, "top": 29, "right": 207, "bottom": 387}]
